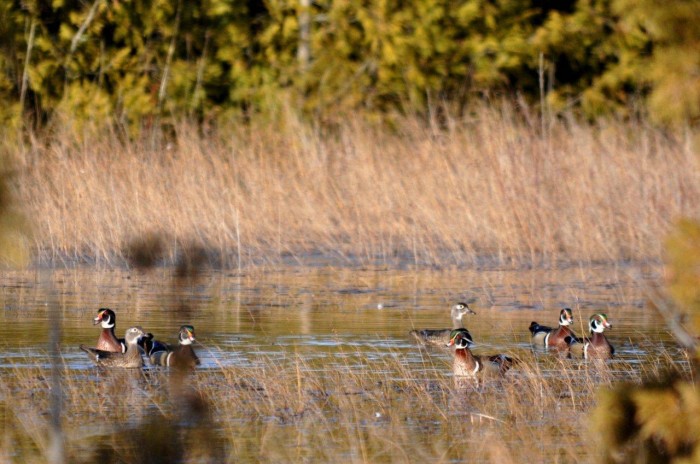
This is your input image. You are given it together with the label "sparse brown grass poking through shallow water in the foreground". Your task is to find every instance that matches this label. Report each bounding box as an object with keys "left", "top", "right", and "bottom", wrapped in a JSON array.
[{"left": 0, "top": 346, "right": 687, "bottom": 463}]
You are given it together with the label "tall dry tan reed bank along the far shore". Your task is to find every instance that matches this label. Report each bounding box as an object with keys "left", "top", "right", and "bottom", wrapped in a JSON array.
[{"left": 6, "top": 105, "right": 700, "bottom": 266}]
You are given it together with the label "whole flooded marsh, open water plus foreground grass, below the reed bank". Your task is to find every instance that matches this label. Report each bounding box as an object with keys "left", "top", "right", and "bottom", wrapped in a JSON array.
[{"left": 0, "top": 265, "right": 688, "bottom": 462}]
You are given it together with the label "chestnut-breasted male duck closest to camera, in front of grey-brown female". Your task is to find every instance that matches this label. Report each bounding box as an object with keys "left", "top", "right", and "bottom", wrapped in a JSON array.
[{"left": 447, "top": 329, "right": 516, "bottom": 378}]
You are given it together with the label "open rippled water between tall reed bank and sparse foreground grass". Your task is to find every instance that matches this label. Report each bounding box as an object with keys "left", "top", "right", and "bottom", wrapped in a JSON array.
[{"left": 0, "top": 265, "right": 685, "bottom": 461}]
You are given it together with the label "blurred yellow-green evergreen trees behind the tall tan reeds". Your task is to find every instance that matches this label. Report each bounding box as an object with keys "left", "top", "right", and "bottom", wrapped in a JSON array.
[{"left": 0, "top": 0, "right": 700, "bottom": 131}]
